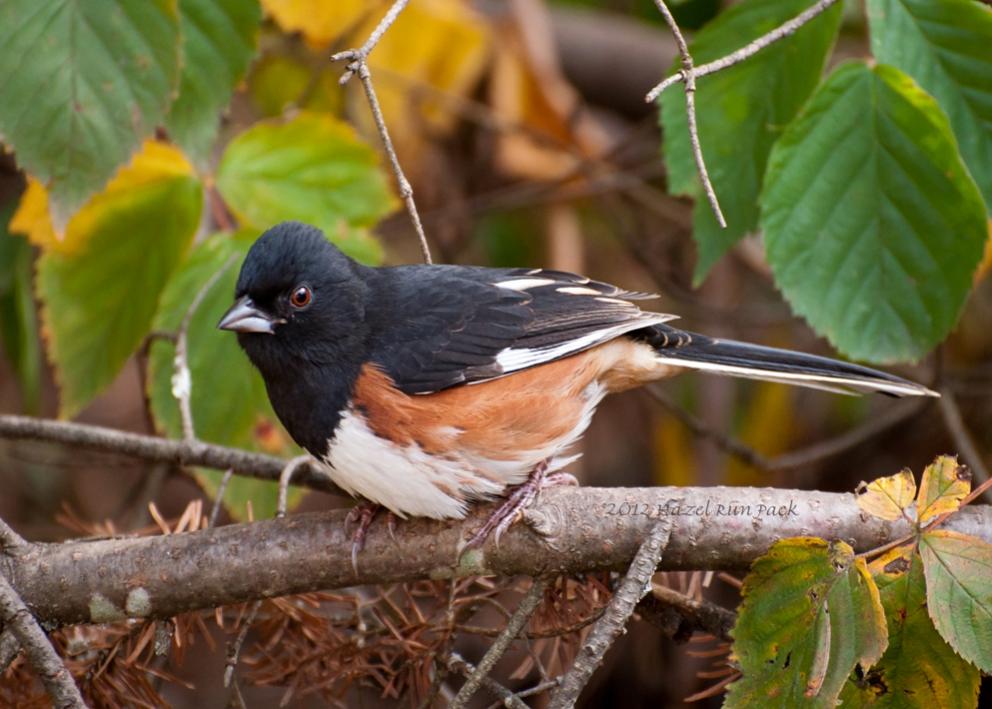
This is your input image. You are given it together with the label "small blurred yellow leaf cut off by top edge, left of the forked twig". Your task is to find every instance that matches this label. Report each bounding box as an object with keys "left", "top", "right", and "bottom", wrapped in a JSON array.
[{"left": 262, "top": 0, "right": 384, "bottom": 50}]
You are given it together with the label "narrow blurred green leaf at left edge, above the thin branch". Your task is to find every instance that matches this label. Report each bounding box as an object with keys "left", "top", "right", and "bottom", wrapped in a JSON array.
[{"left": 0, "top": 203, "right": 41, "bottom": 414}]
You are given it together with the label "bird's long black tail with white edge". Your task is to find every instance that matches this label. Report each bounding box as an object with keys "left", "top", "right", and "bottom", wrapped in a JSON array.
[{"left": 638, "top": 325, "right": 940, "bottom": 396}]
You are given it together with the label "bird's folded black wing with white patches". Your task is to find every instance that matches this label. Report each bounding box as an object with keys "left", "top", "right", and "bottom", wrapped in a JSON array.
[{"left": 367, "top": 266, "right": 675, "bottom": 394}]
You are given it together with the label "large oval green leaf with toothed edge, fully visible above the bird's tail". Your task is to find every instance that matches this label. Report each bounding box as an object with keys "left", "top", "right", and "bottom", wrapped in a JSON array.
[{"left": 761, "top": 62, "right": 987, "bottom": 362}]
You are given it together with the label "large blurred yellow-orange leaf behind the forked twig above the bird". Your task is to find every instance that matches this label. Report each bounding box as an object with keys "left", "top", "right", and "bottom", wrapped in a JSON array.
[{"left": 350, "top": 0, "right": 490, "bottom": 160}]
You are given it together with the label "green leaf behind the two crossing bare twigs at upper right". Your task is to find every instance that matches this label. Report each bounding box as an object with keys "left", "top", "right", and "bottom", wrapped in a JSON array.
[{"left": 661, "top": 0, "right": 842, "bottom": 283}]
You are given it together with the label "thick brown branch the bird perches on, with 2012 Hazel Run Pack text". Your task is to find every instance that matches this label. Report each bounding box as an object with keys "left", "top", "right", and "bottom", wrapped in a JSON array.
[{"left": 7, "top": 487, "right": 992, "bottom": 624}]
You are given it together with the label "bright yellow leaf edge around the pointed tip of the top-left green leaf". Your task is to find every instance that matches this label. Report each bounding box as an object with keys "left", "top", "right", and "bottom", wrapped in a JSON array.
[{"left": 10, "top": 140, "right": 193, "bottom": 254}]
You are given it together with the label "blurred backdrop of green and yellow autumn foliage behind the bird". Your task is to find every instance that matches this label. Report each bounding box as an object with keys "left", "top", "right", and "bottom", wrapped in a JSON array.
[{"left": 0, "top": 0, "right": 992, "bottom": 705}]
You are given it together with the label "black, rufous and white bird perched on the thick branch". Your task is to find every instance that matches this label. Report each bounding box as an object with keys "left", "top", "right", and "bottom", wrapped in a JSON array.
[{"left": 218, "top": 222, "right": 937, "bottom": 552}]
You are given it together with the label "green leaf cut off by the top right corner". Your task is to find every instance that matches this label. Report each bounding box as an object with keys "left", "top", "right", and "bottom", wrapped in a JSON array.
[{"left": 868, "top": 0, "right": 992, "bottom": 211}]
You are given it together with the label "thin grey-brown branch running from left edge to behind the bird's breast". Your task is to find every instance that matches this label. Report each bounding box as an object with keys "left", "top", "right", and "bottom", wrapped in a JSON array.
[{"left": 0, "top": 415, "right": 346, "bottom": 495}]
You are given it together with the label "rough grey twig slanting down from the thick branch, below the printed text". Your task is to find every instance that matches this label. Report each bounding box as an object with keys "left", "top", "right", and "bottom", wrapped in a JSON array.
[{"left": 548, "top": 519, "right": 673, "bottom": 709}]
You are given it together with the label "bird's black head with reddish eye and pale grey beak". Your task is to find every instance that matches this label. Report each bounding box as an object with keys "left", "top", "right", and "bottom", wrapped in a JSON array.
[{"left": 218, "top": 222, "right": 370, "bottom": 376}]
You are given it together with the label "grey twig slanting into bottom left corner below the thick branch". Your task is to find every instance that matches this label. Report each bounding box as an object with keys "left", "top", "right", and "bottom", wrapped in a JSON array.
[{"left": 0, "top": 575, "right": 86, "bottom": 709}]
